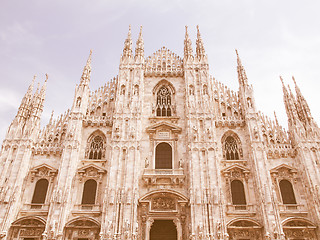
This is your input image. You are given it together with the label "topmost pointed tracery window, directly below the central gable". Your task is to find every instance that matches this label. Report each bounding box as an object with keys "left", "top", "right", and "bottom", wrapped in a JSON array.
[{"left": 156, "top": 86, "right": 172, "bottom": 117}]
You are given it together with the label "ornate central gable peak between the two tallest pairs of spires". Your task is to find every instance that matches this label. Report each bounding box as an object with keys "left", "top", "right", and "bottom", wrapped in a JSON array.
[{"left": 145, "top": 47, "right": 183, "bottom": 77}]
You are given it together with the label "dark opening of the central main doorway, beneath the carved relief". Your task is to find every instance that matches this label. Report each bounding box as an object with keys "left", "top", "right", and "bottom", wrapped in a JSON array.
[{"left": 150, "top": 220, "right": 177, "bottom": 240}]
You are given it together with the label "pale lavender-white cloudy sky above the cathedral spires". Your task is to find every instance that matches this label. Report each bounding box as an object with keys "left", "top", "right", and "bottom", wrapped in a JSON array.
[{"left": 0, "top": 0, "right": 320, "bottom": 142}]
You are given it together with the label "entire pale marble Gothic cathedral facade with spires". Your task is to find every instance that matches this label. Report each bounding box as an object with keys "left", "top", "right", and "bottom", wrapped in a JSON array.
[{"left": 0, "top": 28, "right": 320, "bottom": 240}]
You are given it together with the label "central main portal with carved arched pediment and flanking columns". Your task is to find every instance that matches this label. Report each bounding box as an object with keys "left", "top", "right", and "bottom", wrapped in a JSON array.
[{"left": 138, "top": 189, "right": 190, "bottom": 240}]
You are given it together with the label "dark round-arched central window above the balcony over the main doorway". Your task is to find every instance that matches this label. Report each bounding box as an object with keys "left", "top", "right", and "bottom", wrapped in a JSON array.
[{"left": 155, "top": 143, "right": 172, "bottom": 169}]
